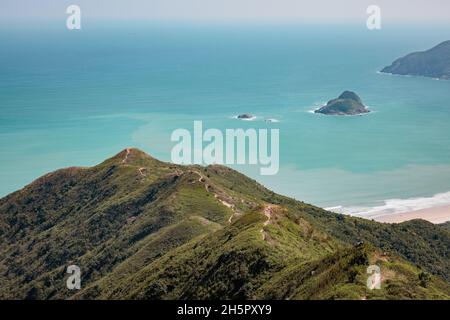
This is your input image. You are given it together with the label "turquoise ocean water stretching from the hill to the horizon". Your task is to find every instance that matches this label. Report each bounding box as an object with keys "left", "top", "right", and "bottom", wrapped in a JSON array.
[{"left": 0, "top": 21, "right": 450, "bottom": 216}]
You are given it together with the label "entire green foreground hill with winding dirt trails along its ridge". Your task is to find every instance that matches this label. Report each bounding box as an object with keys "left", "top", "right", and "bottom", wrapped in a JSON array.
[{"left": 0, "top": 149, "right": 450, "bottom": 299}]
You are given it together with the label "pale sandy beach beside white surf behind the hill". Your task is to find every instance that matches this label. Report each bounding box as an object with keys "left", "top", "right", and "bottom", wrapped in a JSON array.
[{"left": 373, "top": 204, "right": 450, "bottom": 224}]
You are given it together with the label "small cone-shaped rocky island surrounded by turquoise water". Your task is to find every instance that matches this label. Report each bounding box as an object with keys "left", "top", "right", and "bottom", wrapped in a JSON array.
[{"left": 314, "top": 91, "right": 370, "bottom": 116}]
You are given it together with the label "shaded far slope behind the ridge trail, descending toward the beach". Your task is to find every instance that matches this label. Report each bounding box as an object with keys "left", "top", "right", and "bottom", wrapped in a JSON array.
[{"left": 204, "top": 167, "right": 450, "bottom": 281}]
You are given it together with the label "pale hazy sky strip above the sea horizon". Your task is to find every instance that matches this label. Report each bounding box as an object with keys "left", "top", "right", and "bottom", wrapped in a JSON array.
[{"left": 0, "top": 0, "right": 450, "bottom": 23}]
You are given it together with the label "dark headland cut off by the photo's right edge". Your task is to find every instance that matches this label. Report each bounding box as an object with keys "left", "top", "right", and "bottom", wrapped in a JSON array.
[{"left": 381, "top": 40, "right": 450, "bottom": 80}]
